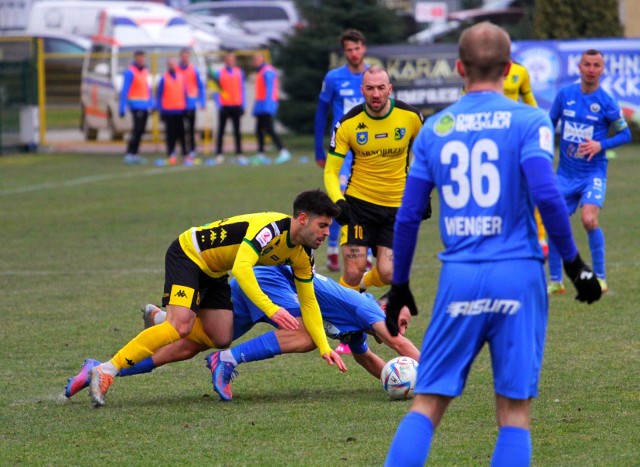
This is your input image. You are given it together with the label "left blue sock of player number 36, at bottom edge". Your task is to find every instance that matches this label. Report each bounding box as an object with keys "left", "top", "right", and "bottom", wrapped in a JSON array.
[{"left": 384, "top": 412, "right": 434, "bottom": 467}]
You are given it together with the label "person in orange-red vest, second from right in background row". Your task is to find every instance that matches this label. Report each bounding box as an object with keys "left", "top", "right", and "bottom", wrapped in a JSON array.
[{"left": 211, "top": 52, "right": 249, "bottom": 165}]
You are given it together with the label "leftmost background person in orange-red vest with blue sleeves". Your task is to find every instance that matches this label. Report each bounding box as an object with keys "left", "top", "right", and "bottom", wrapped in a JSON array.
[{"left": 118, "top": 50, "right": 153, "bottom": 164}]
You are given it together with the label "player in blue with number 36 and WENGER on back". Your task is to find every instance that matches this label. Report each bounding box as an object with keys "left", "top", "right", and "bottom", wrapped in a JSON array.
[{"left": 386, "top": 22, "right": 601, "bottom": 466}]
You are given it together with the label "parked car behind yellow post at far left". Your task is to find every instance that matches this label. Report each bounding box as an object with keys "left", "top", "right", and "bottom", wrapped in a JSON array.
[{"left": 1, "top": 31, "right": 91, "bottom": 104}]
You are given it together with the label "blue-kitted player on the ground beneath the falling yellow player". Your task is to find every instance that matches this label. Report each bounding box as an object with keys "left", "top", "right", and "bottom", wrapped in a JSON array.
[{"left": 65, "top": 266, "right": 420, "bottom": 400}]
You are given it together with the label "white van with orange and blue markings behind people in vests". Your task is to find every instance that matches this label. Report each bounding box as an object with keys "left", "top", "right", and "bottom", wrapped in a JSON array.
[{"left": 80, "top": 2, "right": 214, "bottom": 140}]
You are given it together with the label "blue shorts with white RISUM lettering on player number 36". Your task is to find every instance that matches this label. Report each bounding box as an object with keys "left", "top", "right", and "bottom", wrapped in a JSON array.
[{"left": 415, "top": 259, "right": 548, "bottom": 399}]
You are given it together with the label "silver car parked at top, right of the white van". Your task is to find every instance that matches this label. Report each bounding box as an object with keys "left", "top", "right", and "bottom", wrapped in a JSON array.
[{"left": 184, "top": 0, "right": 305, "bottom": 42}]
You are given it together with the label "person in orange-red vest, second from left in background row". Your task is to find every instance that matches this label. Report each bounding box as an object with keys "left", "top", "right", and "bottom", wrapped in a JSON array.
[{"left": 156, "top": 58, "right": 193, "bottom": 165}]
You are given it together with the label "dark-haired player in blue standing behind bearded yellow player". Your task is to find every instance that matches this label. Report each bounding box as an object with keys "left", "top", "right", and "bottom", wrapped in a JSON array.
[{"left": 314, "top": 29, "right": 367, "bottom": 271}]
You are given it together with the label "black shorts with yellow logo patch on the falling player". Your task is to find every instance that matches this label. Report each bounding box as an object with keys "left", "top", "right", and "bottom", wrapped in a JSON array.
[{"left": 162, "top": 240, "right": 233, "bottom": 313}]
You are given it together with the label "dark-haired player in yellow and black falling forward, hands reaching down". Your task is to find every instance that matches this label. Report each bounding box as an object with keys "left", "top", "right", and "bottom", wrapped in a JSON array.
[{"left": 89, "top": 190, "right": 346, "bottom": 407}]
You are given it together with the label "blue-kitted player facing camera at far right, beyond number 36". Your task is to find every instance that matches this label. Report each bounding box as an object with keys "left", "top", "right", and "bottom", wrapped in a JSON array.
[{"left": 548, "top": 49, "right": 631, "bottom": 293}]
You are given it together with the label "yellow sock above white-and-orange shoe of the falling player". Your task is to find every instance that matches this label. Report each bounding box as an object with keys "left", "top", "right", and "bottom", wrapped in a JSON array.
[{"left": 111, "top": 321, "right": 180, "bottom": 370}]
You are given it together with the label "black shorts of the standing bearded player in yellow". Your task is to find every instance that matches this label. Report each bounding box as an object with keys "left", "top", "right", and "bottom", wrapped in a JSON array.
[{"left": 340, "top": 195, "right": 398, "bottom": 254}]
